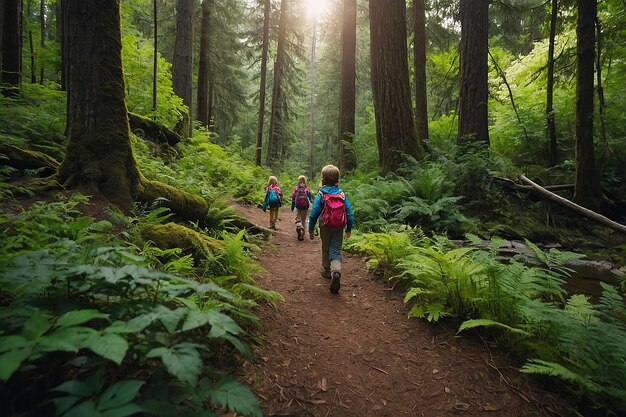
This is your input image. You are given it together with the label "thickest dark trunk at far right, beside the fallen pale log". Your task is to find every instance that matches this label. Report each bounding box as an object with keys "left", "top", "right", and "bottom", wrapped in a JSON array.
[{"left": 574, "top": 0, "right": 603, "bottom": 211}]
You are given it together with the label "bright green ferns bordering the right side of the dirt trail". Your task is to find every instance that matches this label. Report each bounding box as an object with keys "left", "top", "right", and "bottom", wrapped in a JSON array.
[{"left": 347, "top": 228, "right": 626, "bottom": 415}]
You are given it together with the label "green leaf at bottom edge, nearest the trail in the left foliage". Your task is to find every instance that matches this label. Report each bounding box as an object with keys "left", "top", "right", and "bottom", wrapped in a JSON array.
[{"left": 209, "top": 375, "right": 263, "bottom": 417}]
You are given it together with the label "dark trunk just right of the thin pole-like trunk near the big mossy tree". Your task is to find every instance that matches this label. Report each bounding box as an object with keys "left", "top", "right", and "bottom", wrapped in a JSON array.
[{"left": 172, "top": 0, "right": 194, "bottom": 136}]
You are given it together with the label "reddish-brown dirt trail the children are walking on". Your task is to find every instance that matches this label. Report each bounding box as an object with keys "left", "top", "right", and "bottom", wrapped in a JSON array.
[{"left": 237, "top": 207, "right": 565, "bottom": 417}]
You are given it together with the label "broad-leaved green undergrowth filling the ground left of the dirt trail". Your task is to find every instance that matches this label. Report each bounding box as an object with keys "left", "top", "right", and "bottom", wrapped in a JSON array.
[{"left": 0, "top": 194, "right": 282, "bottom": 417}]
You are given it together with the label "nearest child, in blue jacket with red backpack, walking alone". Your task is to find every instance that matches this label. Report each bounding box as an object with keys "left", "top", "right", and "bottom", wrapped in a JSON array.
[{"left": 309, "top": 165, "right": 354, "bottom": 294}]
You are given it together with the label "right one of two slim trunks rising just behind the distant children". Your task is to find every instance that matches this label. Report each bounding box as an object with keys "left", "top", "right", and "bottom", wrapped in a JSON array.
[{"left": 265, "top": 0, "right": 288, "bottom": 167}]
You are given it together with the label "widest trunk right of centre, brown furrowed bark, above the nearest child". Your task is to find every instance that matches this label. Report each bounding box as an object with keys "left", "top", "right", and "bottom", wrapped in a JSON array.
[{"left": 369, "top": 0, "right": 423, "bottom": 173}]
